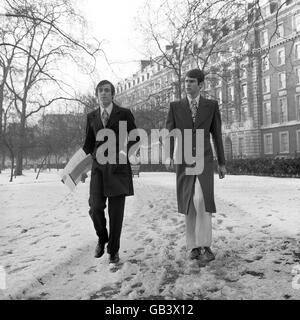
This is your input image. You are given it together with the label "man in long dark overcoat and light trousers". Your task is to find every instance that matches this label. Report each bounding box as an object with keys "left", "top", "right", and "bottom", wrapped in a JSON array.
[{"left": 166, "top": 69, "right": 226, "bottom": 263}]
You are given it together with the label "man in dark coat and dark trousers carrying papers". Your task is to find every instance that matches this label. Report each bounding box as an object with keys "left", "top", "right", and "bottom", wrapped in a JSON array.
[{"left": 83, "top": 80, "right": 136, "bottom": 263}]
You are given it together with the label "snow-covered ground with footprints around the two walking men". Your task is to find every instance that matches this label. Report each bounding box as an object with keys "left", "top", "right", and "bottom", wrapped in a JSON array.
[{"left": 0, "top": 171, "right": 300, "bottom": 299}]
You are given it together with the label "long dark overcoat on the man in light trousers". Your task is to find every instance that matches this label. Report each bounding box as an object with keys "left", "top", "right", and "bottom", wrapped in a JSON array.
[{"left": 166, "top": 96, "right": 225, "bottom": 214}]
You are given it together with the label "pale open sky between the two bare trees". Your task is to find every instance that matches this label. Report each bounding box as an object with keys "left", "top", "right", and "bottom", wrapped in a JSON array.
[{"left": 77, "top": 0, "right": 149, "bottom": 92}]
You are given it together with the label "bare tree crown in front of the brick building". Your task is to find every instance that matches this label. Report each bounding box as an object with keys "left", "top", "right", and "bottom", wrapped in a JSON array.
[{"left": 137, "top": 0, "right": 286, "bottom": 98}]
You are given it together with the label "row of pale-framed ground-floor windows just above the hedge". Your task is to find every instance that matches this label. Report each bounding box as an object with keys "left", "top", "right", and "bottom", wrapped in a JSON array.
[{"left": 264, "top": 130, "right": 300, "bottom": 154}]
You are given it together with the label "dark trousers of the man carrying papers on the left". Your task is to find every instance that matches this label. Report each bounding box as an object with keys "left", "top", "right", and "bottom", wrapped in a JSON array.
[{"left": 89, "top": 168, "right": 125, "bottom": 255}]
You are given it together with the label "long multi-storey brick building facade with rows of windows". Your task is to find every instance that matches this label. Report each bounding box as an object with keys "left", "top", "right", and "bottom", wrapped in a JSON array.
[{"left": 117, "top": 0, "right": 300, "bottom": 159}]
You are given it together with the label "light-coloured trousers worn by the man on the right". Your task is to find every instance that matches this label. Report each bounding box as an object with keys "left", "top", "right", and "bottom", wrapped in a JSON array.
[{"left": 185, "top": 177, "right": 212, "bottom": 250}]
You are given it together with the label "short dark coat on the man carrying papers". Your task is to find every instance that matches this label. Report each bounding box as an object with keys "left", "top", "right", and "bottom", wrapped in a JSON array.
[{"left": 83, "top": 103, "right": 136, "bottom": 197}]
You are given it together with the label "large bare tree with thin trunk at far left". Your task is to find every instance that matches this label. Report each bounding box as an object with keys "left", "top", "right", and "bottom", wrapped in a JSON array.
[{"left": 1, "top": 0, "right": 99, "bottom": 175}]
